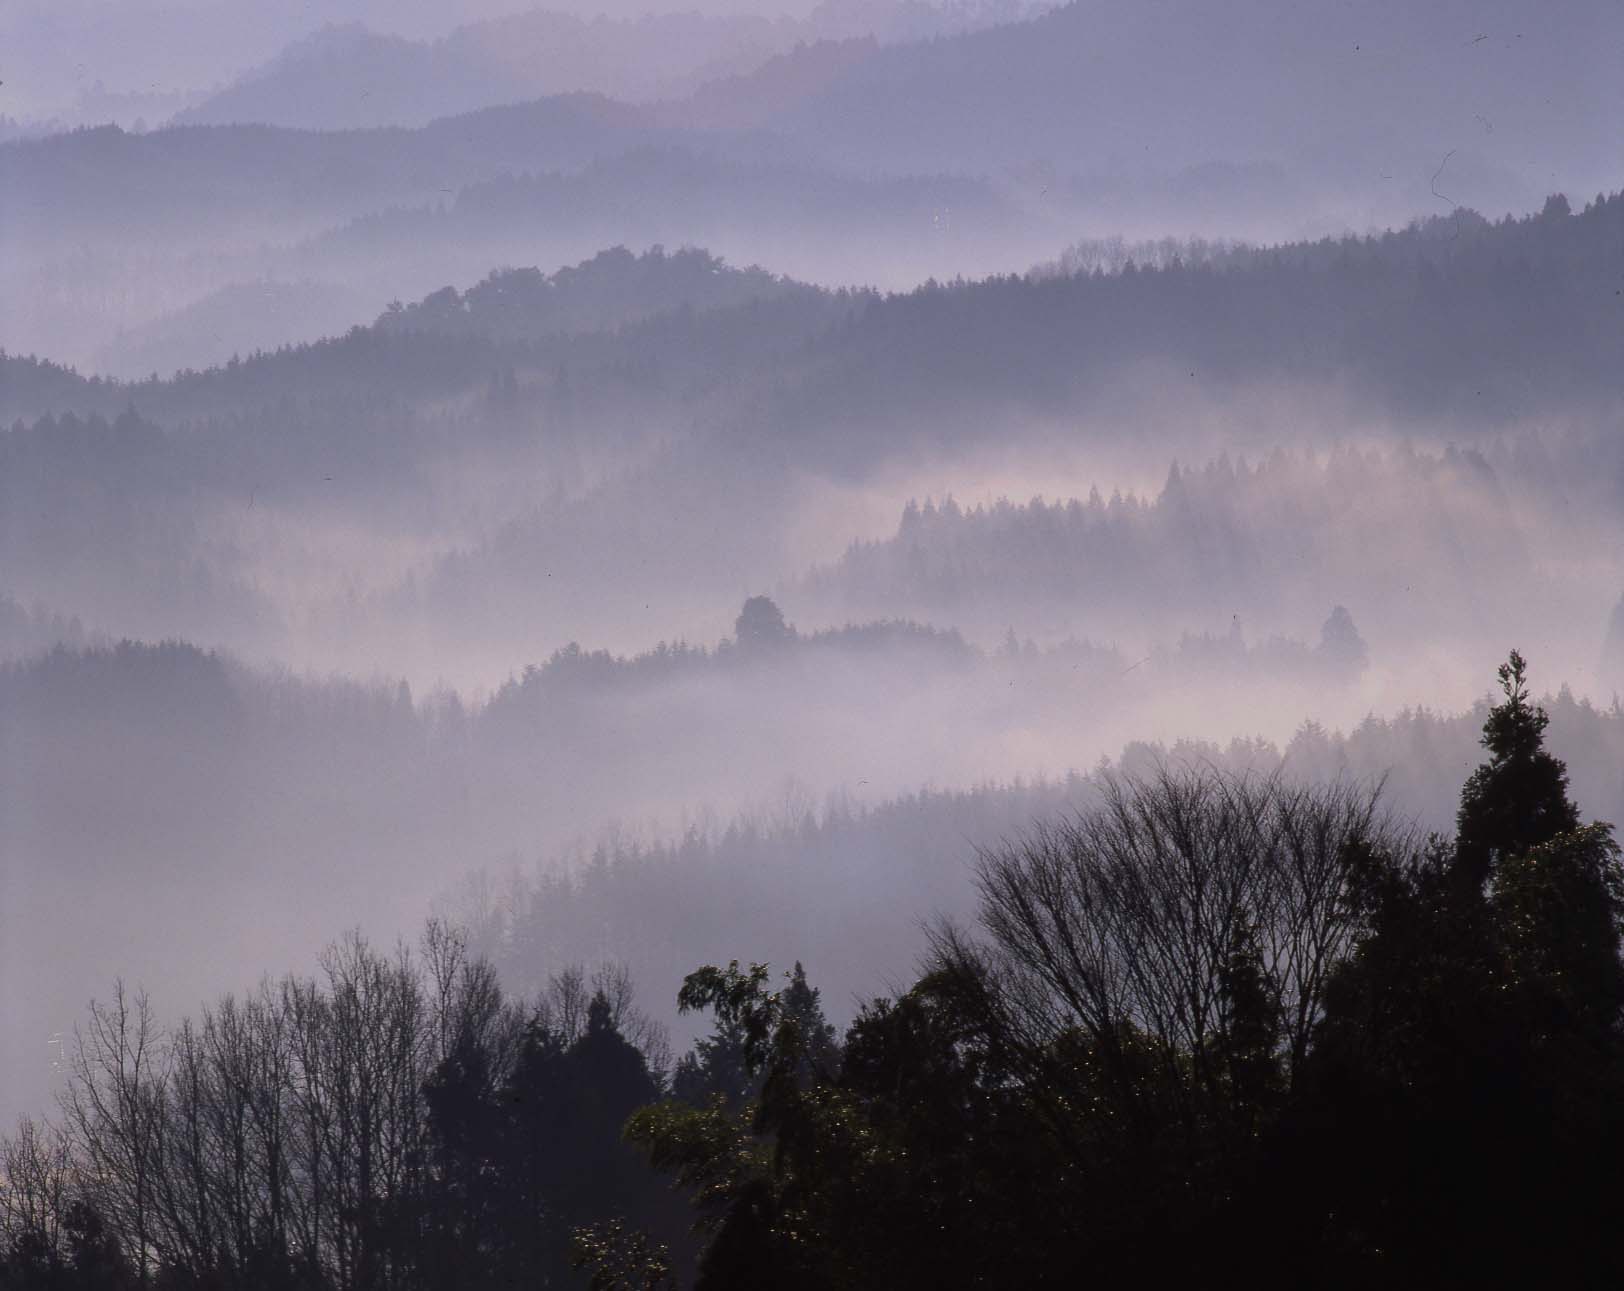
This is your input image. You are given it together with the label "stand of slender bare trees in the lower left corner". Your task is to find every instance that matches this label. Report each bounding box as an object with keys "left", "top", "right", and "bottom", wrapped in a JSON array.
[{"left": 0, "top": 921, "right": 669, "bottom": 1291}]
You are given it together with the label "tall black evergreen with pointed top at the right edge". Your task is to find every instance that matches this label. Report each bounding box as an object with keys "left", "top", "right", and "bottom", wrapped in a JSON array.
[{"left": 1281, "top": 651, "right": 1624, "bottom": 1285}]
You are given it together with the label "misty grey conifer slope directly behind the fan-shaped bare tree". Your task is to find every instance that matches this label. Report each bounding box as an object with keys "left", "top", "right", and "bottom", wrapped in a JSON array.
[{"left": 451, "top": 669, "right": 1624, "bottom": 1065}]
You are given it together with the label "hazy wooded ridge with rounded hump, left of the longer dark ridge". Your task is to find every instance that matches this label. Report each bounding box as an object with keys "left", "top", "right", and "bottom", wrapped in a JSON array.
[{"left": 0, "top": 252, "right": 872, "bottom": 435}]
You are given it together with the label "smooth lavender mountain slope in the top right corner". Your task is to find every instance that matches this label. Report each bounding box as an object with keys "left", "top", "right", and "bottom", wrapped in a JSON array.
[{"left": 757, "top": 0, "right": 1624, "bottom": 211}]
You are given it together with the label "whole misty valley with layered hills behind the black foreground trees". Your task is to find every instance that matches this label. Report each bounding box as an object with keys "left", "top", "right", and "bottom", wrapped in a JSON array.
[{"left": 0, "top": 0, "right": 1624, "bottom": 1288}]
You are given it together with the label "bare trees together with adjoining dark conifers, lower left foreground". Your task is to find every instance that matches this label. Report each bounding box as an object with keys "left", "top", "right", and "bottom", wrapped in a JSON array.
[{"left": 0, "top": 922, "right": 682, "bottom": 1291}]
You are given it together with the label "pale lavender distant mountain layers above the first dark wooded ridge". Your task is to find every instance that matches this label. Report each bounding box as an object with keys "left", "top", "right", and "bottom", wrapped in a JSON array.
[{"left": 9, "top": 3, "right": 1621, "bottom": 375}]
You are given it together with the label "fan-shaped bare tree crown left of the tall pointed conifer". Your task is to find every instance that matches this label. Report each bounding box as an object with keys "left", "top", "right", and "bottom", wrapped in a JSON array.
[{"left": 934, "top": 765, "right": 1413, "bottom": 1130}]
